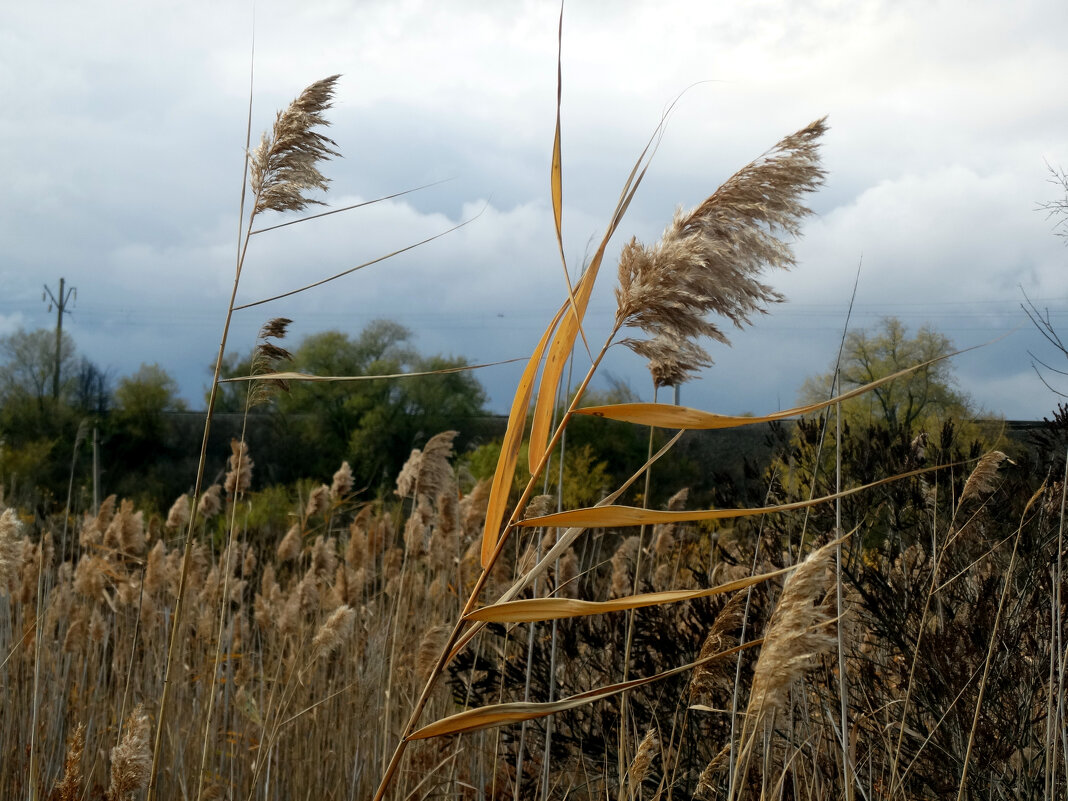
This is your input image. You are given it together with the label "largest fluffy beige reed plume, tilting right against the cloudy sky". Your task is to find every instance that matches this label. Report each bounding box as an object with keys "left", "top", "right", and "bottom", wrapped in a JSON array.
[{"left": 615, "top": 117, "right": 827, "bottom": 387}]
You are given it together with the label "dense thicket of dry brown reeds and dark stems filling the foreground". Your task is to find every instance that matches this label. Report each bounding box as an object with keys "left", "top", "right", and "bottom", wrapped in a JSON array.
[{"left": 0, "top": 420, "right": 1066, "bottom": 799}]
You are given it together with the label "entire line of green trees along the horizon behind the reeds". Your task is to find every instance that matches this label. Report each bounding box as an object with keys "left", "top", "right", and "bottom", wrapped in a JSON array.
[{"left": 0, "top": 318, "right": 1055, "bottom": 529}]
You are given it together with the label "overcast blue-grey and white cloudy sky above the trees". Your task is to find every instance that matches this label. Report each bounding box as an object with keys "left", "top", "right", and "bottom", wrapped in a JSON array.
[{"left": 0, "top": 0, "right": 1068, "bottom": 427}]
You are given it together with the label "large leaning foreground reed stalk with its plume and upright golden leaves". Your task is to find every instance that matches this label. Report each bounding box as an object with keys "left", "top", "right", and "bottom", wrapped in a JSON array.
[{"left": 375, "top": 83, "right": 826, "bottom": 801}]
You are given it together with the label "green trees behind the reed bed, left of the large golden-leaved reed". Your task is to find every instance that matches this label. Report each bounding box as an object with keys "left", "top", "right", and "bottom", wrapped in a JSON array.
[{"left": 0, "top": 320, "right": 487, "bottom": 514}]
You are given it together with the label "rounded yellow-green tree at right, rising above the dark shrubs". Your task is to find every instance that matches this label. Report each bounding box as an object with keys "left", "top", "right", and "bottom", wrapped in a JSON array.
[{"left": 771, "top": 317, "right": 986, "bottom": 544}]
